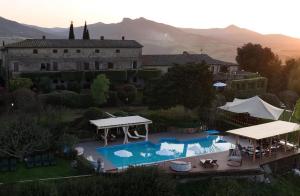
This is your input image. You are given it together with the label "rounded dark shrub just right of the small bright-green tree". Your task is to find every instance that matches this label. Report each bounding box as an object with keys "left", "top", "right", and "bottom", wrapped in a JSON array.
[{"left": 117, "top": 84, "right": 137, "bottom": 104}]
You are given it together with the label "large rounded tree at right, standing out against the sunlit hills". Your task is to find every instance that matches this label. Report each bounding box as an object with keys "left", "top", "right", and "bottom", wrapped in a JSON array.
[{"left": 236, "top": 43, "right": 281, "bottom": 92}]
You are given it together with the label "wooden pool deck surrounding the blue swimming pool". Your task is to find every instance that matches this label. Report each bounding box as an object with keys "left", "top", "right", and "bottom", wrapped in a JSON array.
[{"left": 77, "top": 132, "right": 300, "bottom": 175}]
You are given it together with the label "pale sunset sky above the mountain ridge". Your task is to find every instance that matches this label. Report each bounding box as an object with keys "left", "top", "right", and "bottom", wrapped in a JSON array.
[{"left": 0, "top": 0, "right": 300, "bottom": 38}]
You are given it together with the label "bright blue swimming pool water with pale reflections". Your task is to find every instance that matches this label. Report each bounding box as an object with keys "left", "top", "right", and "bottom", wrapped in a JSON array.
[{"left": 96, "top": 135, "right": 234, "bottom": 168}]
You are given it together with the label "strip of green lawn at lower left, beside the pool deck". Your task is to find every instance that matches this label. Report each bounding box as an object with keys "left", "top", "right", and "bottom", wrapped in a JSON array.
[{"left": 0, "top": 159, "right": 76, "bottom": 183}]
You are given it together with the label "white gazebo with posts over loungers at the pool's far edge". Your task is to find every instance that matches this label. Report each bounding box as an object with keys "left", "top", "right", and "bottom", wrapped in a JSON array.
[{"left": 90, "top": 116, "right": 152, "bottom": 145}]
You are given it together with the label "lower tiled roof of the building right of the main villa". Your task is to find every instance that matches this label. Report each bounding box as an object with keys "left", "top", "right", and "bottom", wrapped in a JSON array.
[{"left": 142, "top": 53, "right": 236, "bottom": 66}]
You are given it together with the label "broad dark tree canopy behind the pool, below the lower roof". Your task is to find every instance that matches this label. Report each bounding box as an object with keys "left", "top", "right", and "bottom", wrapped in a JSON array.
[{"left": 145, "top": 62, "right": 214, "bottom": 109}]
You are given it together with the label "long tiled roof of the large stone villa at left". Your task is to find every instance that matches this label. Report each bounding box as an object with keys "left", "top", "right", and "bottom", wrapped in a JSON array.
[{"left": 5, "top": 39, "right": 143, "bottom": 48}]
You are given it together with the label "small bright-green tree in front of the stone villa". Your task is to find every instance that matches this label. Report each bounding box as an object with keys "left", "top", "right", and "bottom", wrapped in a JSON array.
[{"left": 91, "top": 74, "right": 110, "bottom": 105}]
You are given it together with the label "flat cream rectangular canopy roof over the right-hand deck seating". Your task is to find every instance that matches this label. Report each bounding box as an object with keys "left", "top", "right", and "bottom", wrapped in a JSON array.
[{"left": 227, "top": 120, "right": 300, "bottom": 140}]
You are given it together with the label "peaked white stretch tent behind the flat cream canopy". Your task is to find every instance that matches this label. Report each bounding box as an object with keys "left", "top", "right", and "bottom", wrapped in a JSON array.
[{"left": 219, "top": 96, "right": 284, "bottom": 120}]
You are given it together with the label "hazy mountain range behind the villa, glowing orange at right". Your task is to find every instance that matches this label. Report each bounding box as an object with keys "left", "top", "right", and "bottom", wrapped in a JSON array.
[{"left": 0, "top": 17, "right": 300, "bottom": 62}]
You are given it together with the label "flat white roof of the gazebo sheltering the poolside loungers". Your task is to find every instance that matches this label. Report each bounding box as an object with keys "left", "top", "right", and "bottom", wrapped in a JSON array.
[{"left": 90, "top": 116, "right": 152, "bottom": 129}]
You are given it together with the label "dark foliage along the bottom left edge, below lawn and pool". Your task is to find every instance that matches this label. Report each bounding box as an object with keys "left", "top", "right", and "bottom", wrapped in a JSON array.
[{"left": 0, "top": 167, "right": 177, "bottom": 196}]
